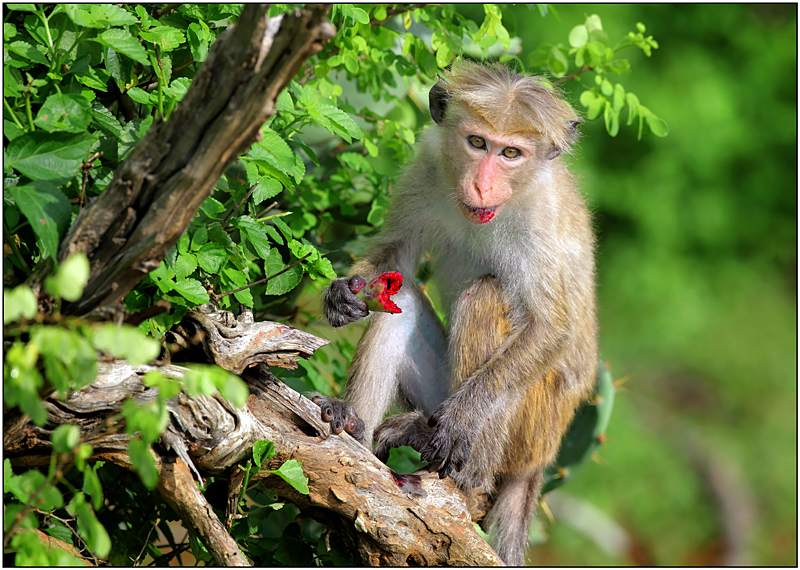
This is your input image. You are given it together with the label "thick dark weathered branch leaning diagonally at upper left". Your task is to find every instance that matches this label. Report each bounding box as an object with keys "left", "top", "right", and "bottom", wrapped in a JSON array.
[{"left": 53, "top": 4, "right": 335, "bottom": 315}]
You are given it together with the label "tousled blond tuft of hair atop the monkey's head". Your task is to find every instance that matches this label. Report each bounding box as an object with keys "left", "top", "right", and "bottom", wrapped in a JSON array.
[{"left": 431, "top": 59, "right": 581, "bottom": 158}]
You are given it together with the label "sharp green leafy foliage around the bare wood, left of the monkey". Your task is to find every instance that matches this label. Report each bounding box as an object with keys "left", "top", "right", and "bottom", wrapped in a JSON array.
[{"left": 3, "top": 4, "right": 667, "bottom": 566}]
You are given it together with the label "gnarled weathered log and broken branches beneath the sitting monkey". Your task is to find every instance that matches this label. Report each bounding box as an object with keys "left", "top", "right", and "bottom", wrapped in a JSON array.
[{"left": 3, "top": 312, "right": 500, "bottom": 566}]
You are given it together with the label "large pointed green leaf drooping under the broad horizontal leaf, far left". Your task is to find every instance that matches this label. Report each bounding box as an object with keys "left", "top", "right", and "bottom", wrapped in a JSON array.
[{"left": 9, "top": 182, "right": 72, "bottom": 258}]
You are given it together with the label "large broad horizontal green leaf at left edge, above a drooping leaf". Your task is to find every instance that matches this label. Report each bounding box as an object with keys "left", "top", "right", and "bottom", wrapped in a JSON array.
[{"left": 5, "top": 132, "right": 95, "bottom": 181}]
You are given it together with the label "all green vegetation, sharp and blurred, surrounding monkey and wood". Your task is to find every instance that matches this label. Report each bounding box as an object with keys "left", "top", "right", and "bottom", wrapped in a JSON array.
[{"left": 3, "top": 4, "right": 797, "bottom": 566}]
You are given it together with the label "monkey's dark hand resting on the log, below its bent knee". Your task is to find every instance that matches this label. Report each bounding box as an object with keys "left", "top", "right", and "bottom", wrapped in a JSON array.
[{"left": 419, "top": 398, "right": 478, "bottom": 479}]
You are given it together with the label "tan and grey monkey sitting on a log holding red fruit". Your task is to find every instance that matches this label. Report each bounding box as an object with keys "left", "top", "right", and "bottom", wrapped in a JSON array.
[{"left": 315, "top": 60, "right": 598, "bottom": 566}]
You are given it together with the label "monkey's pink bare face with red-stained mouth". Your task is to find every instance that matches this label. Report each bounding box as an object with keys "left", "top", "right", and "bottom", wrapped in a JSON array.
[{"left": 451, "top": 123, "right": 536, "bottom": 224}]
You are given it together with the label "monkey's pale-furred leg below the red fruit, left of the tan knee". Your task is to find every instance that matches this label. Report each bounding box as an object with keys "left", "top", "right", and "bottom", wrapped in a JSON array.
[{"left": 345, "top": 280, "right": 448, "bottom": 445}]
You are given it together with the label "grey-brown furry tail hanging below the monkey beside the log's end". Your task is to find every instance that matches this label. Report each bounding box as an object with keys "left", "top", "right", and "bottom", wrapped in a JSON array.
[{"left": 485, "top": 468, "right": 544, "bottom": 566}]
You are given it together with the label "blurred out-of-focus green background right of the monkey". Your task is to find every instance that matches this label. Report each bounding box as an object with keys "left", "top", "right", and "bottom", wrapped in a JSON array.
[{"left": 301, "top": 4, "right": 797, "bottom": 566}]
